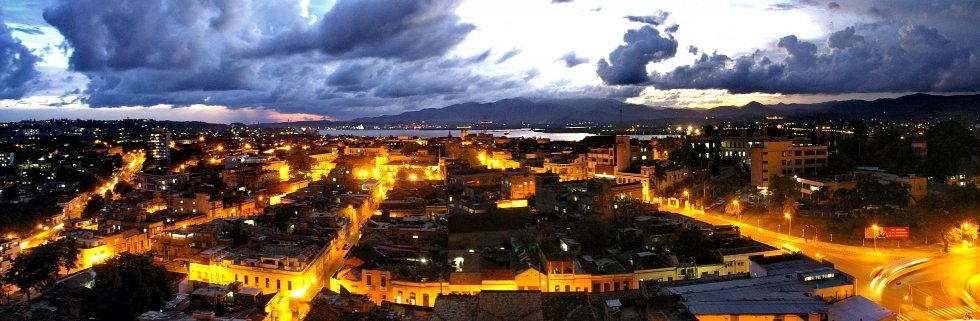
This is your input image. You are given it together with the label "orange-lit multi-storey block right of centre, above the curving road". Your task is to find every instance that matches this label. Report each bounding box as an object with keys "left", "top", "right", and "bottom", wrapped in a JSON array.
[{"left": 749, "top": 141, "right": 827, "bottom": 188}]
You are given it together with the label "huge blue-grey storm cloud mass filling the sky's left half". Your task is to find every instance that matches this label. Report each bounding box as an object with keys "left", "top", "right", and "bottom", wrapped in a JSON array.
[{"left": 44, "top": 0, "right": 490, "bottom": 115}]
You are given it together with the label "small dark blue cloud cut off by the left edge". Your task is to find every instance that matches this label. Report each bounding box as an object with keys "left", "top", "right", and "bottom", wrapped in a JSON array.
[{"left": 0, "top": 11, "right": 38, "bottom": 99}]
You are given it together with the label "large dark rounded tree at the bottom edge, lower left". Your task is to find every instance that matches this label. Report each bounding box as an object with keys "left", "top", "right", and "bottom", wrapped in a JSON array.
[{"left": 87, "top": 253, "right": 173, "bottom": 320}]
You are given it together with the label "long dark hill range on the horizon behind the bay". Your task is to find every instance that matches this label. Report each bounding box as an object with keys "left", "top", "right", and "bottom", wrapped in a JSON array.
[{"left": 336, "top": 94, "right": 980, "bottom": 126}]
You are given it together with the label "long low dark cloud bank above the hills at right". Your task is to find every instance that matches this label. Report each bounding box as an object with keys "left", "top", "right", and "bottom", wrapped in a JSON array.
[{"left": 650, "top": 25, "right": 980, "bottom": 94}]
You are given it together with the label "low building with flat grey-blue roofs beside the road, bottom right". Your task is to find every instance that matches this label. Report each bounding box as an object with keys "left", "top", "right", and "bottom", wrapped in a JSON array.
[{"left": 659, "top": 254, "right": 894, "bottom": 321}]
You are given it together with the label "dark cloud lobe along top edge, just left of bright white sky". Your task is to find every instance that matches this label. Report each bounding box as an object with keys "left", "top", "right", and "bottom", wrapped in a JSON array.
[{"left": 252, "top": 0, "right": 475, "bottom": 60}]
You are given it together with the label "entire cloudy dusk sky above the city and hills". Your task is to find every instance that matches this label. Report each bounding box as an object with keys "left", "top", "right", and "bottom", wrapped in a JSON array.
[{"left": 0, "top": 0, "right": 980, "bottom": 122}]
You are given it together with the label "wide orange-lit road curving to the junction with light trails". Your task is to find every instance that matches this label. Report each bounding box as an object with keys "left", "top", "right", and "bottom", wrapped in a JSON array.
[{"left": 666, "top": 207, "right": 980, "bottom": 321}]
